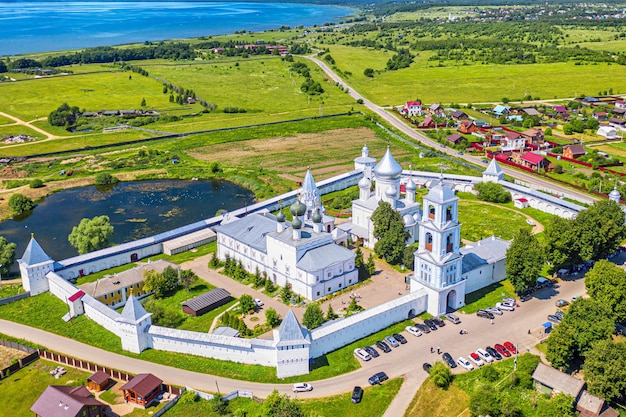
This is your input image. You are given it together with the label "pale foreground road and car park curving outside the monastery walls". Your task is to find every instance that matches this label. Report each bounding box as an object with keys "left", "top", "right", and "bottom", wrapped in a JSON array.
[{"left": 0, "top": 270, "right": 584, "bottom": 406}]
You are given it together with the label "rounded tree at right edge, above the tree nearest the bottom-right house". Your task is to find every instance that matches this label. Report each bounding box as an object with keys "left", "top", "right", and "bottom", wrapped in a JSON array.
[{"left": 585, "top": 260, "right": 626, "bottom": 322}]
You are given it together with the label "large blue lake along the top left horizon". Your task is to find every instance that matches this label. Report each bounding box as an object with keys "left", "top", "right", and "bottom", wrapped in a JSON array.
[{"left": 0, "top": 1, "right": 353, "bottom": 56}]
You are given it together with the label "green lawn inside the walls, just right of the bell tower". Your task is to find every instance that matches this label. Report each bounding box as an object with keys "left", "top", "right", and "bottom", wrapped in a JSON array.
[{"left": 459, "top": 200, "right": 531, "bottom": 242}]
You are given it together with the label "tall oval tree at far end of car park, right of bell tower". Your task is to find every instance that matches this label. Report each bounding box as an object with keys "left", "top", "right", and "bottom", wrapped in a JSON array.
[{"left": 506, "top": 229, "right": 544, "bottom": 294}]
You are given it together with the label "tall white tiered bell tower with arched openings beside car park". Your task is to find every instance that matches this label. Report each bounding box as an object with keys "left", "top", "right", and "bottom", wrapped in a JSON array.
[{"left": 411, "top": 180, "right": 465, "bottom": 316}]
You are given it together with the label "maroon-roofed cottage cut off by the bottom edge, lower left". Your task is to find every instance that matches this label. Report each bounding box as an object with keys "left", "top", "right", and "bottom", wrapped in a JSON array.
[{"left": 30, "top": 385, "right": 109, "bottom": 417}]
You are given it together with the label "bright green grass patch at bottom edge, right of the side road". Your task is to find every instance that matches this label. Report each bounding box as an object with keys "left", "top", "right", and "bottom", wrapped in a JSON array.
[{"left": 404, "top": 378, "right": 471, "bottom": 417}]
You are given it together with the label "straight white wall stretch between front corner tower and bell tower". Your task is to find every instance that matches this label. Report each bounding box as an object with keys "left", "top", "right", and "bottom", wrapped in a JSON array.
[{"left": 311, "top": 291, "right": 426, "bottom": 358}]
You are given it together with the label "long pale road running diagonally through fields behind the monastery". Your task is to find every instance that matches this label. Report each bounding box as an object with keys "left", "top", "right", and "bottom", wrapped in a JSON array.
[{"left": 306, "top": 56, "right": 598, "bottom": 205}]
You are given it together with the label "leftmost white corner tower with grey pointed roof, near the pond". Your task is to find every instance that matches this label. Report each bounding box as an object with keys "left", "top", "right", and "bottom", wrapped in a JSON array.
[{"left": 17, "top": 234, "right": 54, "bottom": 295}]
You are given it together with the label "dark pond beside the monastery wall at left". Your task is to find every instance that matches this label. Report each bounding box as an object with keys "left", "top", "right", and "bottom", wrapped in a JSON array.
[{"left": 0, "top": 180, "right": 254, "bottom": 271}]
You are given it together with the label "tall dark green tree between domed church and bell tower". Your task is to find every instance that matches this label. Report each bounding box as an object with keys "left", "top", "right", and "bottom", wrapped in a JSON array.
[{"left": 371, "top": 201, "right": 407, "bottom": 264}]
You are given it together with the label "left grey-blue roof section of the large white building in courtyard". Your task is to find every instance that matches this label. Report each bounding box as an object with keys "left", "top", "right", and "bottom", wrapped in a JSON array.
[{"left": 215, "top": 213, "right": 276, "bottom": 253}]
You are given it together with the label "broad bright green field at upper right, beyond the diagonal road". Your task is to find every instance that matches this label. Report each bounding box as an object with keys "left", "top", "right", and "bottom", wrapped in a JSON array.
[{"left": 328, "top": 45, "right": 626, "bottom": 105}]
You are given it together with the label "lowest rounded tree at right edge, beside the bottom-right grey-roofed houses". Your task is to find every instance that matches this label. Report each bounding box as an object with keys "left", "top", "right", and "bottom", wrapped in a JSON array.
[{"left": 585, "top": 339, "right": 626, "bottom": 401}]
